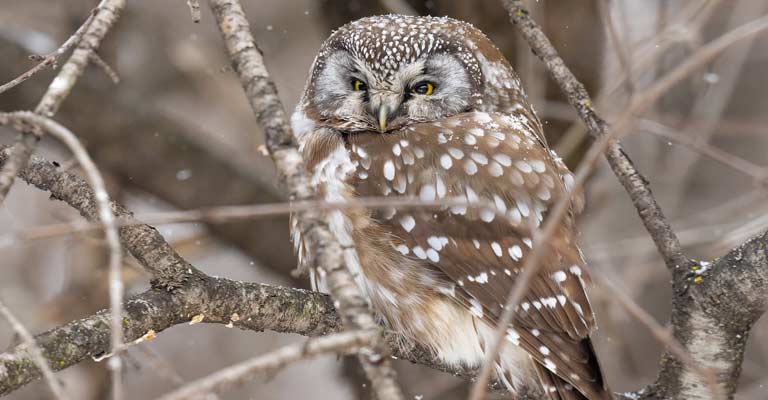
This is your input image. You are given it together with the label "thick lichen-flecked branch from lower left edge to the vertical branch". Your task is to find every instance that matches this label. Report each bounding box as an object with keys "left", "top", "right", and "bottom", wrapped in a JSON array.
[{"left": 0, "top": 277, "right": 341, "bottom": 395}]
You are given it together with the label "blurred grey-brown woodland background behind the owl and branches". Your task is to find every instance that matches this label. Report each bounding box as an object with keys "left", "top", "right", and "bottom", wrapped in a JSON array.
[{"left": 0, "top": 0, "right": 768, "bottom": 400}]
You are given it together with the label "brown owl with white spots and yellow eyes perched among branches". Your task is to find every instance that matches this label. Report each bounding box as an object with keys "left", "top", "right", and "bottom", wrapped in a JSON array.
[{"left": 291, "top": 15, "right": 611, "bottom": 400}]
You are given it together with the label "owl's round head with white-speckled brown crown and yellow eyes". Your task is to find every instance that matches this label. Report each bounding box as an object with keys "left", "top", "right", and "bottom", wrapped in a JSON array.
[{"left": 297, "top": 15, "right": 521, "bottom": 134}]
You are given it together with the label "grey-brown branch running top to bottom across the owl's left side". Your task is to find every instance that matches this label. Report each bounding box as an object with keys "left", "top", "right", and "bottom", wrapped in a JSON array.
[{"left": 204, "top": 0, "right": 403, "bottom": 400}]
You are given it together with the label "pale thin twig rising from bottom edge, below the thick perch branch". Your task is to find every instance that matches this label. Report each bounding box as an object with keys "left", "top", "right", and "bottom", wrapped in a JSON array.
[{"left": 153, "top": 331, "right": 378, "bottom": 400}]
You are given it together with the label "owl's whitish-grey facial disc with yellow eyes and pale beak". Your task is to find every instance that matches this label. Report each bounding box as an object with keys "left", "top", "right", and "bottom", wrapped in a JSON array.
[{"left": 314, "top": 51, "right": 473, "bottom": 132}]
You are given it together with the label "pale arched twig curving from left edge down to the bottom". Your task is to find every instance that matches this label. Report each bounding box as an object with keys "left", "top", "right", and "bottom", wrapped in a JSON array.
[{"left": 0, "top": 111, "right": 123, "bottom": 400}]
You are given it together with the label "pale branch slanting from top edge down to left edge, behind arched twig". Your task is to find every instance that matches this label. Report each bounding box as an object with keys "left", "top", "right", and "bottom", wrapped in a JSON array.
[{"left": 0, "top": 0, "right": 125, "bottom": 204}]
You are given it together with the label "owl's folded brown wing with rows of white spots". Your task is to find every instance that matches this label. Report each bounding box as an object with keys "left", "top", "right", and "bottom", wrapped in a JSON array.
[{"left": 347, "top": 113, "right": 602, "bottom": 398}]
